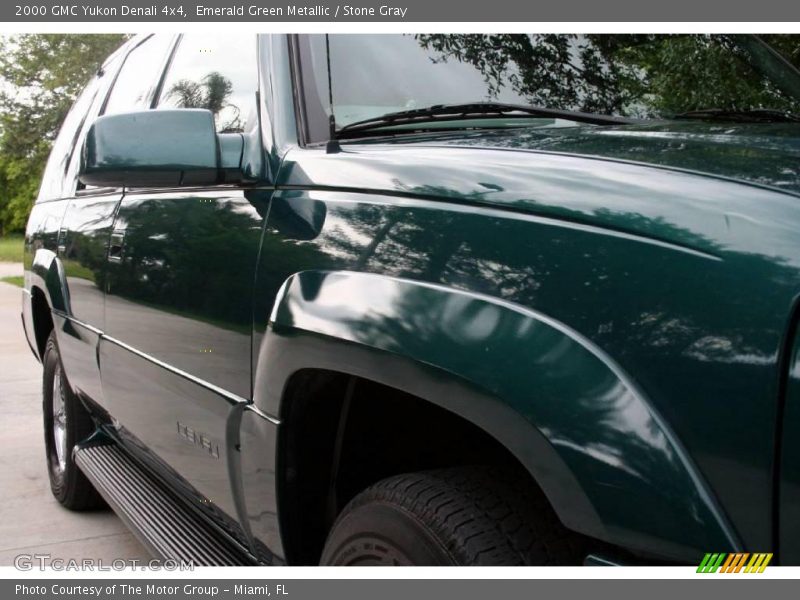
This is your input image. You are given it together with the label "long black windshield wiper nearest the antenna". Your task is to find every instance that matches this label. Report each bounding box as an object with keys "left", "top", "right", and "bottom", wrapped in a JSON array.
[{"left": 335, "top": 102, "right": 636, "bottom": 139}]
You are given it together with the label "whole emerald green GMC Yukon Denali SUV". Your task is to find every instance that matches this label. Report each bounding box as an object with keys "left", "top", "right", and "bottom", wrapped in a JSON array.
[{"left": 18, "top": 35, "right": 800, "bottom": 565}]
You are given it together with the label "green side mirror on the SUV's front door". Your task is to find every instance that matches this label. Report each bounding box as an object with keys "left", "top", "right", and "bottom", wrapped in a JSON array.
[{"left": 78, "top": 109, "right": 244, "bottom": 187}]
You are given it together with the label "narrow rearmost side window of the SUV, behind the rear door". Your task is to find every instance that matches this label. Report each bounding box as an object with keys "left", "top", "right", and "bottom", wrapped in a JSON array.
[{"left": 37, "top": 71, "right": 103, "bottom": 202}]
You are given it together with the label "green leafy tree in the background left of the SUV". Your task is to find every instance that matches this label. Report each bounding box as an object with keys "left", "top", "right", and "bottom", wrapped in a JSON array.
[{"left": 0, "top": 34, "right": 126, "bottom": 235}]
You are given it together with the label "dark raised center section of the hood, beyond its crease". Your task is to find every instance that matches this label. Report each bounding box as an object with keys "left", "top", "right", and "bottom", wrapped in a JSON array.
[{"left": 424, "top": 121, "right": 800, "bottom": 194}]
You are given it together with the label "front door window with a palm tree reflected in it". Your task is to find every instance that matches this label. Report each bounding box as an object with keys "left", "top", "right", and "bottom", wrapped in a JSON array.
[{"left": 156, "top": 34, "right": 258, "bottom": 133}]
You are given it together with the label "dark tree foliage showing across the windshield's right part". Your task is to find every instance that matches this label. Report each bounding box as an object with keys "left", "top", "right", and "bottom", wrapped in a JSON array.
[{"left": 417, "top": 34, "right": 800, "bottom": 118}]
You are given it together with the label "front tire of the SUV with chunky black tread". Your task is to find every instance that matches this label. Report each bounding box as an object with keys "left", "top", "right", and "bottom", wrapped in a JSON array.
[{"left": 321, "top": 467, "right": 586, "bottom": 565}]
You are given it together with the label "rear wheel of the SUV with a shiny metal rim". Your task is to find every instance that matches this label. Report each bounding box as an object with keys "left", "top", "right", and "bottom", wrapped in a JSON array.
[{"left": 42, "top": 332, "right": 105, "bottom": 510}]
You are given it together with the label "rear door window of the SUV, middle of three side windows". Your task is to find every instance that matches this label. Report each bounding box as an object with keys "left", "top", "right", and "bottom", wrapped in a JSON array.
[{"left": 103, "top": 35, "right": 172, "bottom": 115}]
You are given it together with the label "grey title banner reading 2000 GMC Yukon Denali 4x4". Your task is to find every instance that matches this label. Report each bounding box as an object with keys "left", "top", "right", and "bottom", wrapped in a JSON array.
[{"left": 0, "top": 0, "right": 800, "bottom": 21}]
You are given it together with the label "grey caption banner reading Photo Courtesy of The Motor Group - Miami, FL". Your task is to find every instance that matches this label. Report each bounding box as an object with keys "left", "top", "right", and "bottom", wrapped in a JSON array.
[{"left": 0, "top": 580, "right": 797, "bottom": 600}]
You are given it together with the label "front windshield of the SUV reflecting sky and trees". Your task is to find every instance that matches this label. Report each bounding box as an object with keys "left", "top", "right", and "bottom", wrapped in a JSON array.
[{"left": 301, "top": 34, "right": 800, "bottom": 134}]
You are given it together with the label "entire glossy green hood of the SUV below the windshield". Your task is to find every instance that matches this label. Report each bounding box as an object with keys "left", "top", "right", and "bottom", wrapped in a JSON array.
[{"left": 276, "top": 122, "right": 800, "bottom": 266}]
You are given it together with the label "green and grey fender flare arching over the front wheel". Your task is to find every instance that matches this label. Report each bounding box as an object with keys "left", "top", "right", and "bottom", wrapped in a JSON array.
[{"left": 254, "top": 271, "right": 742, "bottom": 561}]
